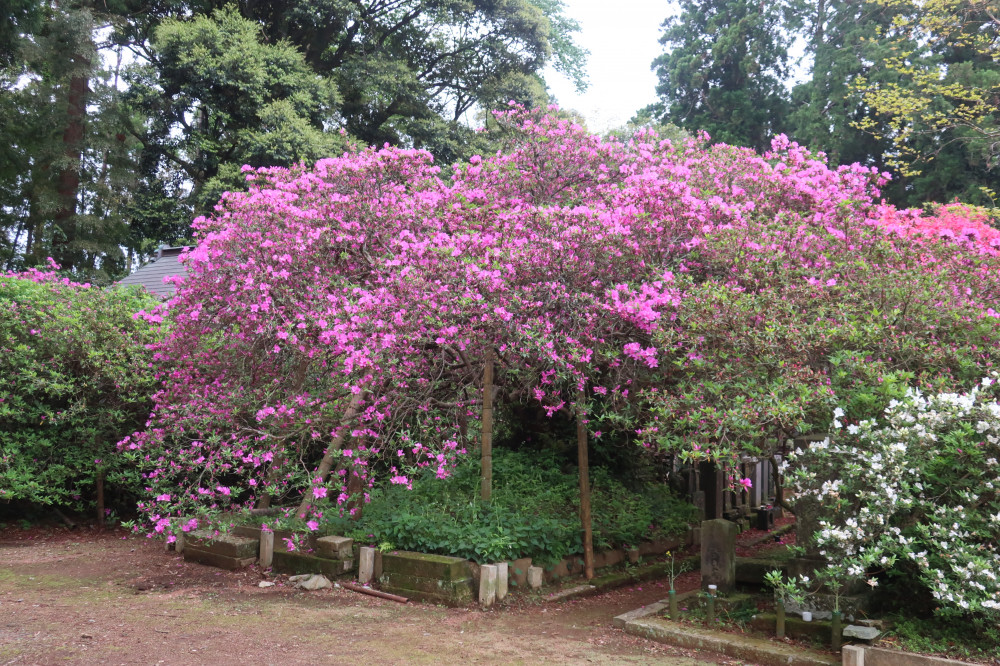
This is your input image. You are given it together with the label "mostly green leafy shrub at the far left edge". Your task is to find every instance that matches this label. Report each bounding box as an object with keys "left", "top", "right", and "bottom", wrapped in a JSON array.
[{"left": 0, "top": 267, "right": 159, "bottom": 521}]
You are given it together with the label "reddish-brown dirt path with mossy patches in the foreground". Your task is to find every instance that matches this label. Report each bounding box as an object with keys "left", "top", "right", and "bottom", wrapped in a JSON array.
[{"left": 0, "top": 530, "right": 752, "bottom": 666}]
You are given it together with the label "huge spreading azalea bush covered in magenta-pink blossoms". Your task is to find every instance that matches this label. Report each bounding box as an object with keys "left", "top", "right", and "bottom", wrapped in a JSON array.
[{"left": 120, "top": 109, "right": 1000, "bottom": 548}]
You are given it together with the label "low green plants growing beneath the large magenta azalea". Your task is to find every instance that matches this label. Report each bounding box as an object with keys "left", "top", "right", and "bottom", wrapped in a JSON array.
[{"left": 320, "top": 449, "right": 695, "bottom": 565}]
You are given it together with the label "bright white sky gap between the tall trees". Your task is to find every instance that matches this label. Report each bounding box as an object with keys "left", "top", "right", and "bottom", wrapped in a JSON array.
[{"left": 544, "top": 0, "right": 675, "bottom": 132}]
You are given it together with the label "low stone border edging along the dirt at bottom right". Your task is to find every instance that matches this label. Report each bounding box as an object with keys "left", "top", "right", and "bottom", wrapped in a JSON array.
[{"left": 624, "top": 617, "right": 836, "bottom": 666}]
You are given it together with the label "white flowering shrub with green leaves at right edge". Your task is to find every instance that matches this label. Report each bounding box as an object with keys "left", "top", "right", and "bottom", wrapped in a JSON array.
[{"left": 783, "top": 373, "right": 1000, "bottom": 619}]
